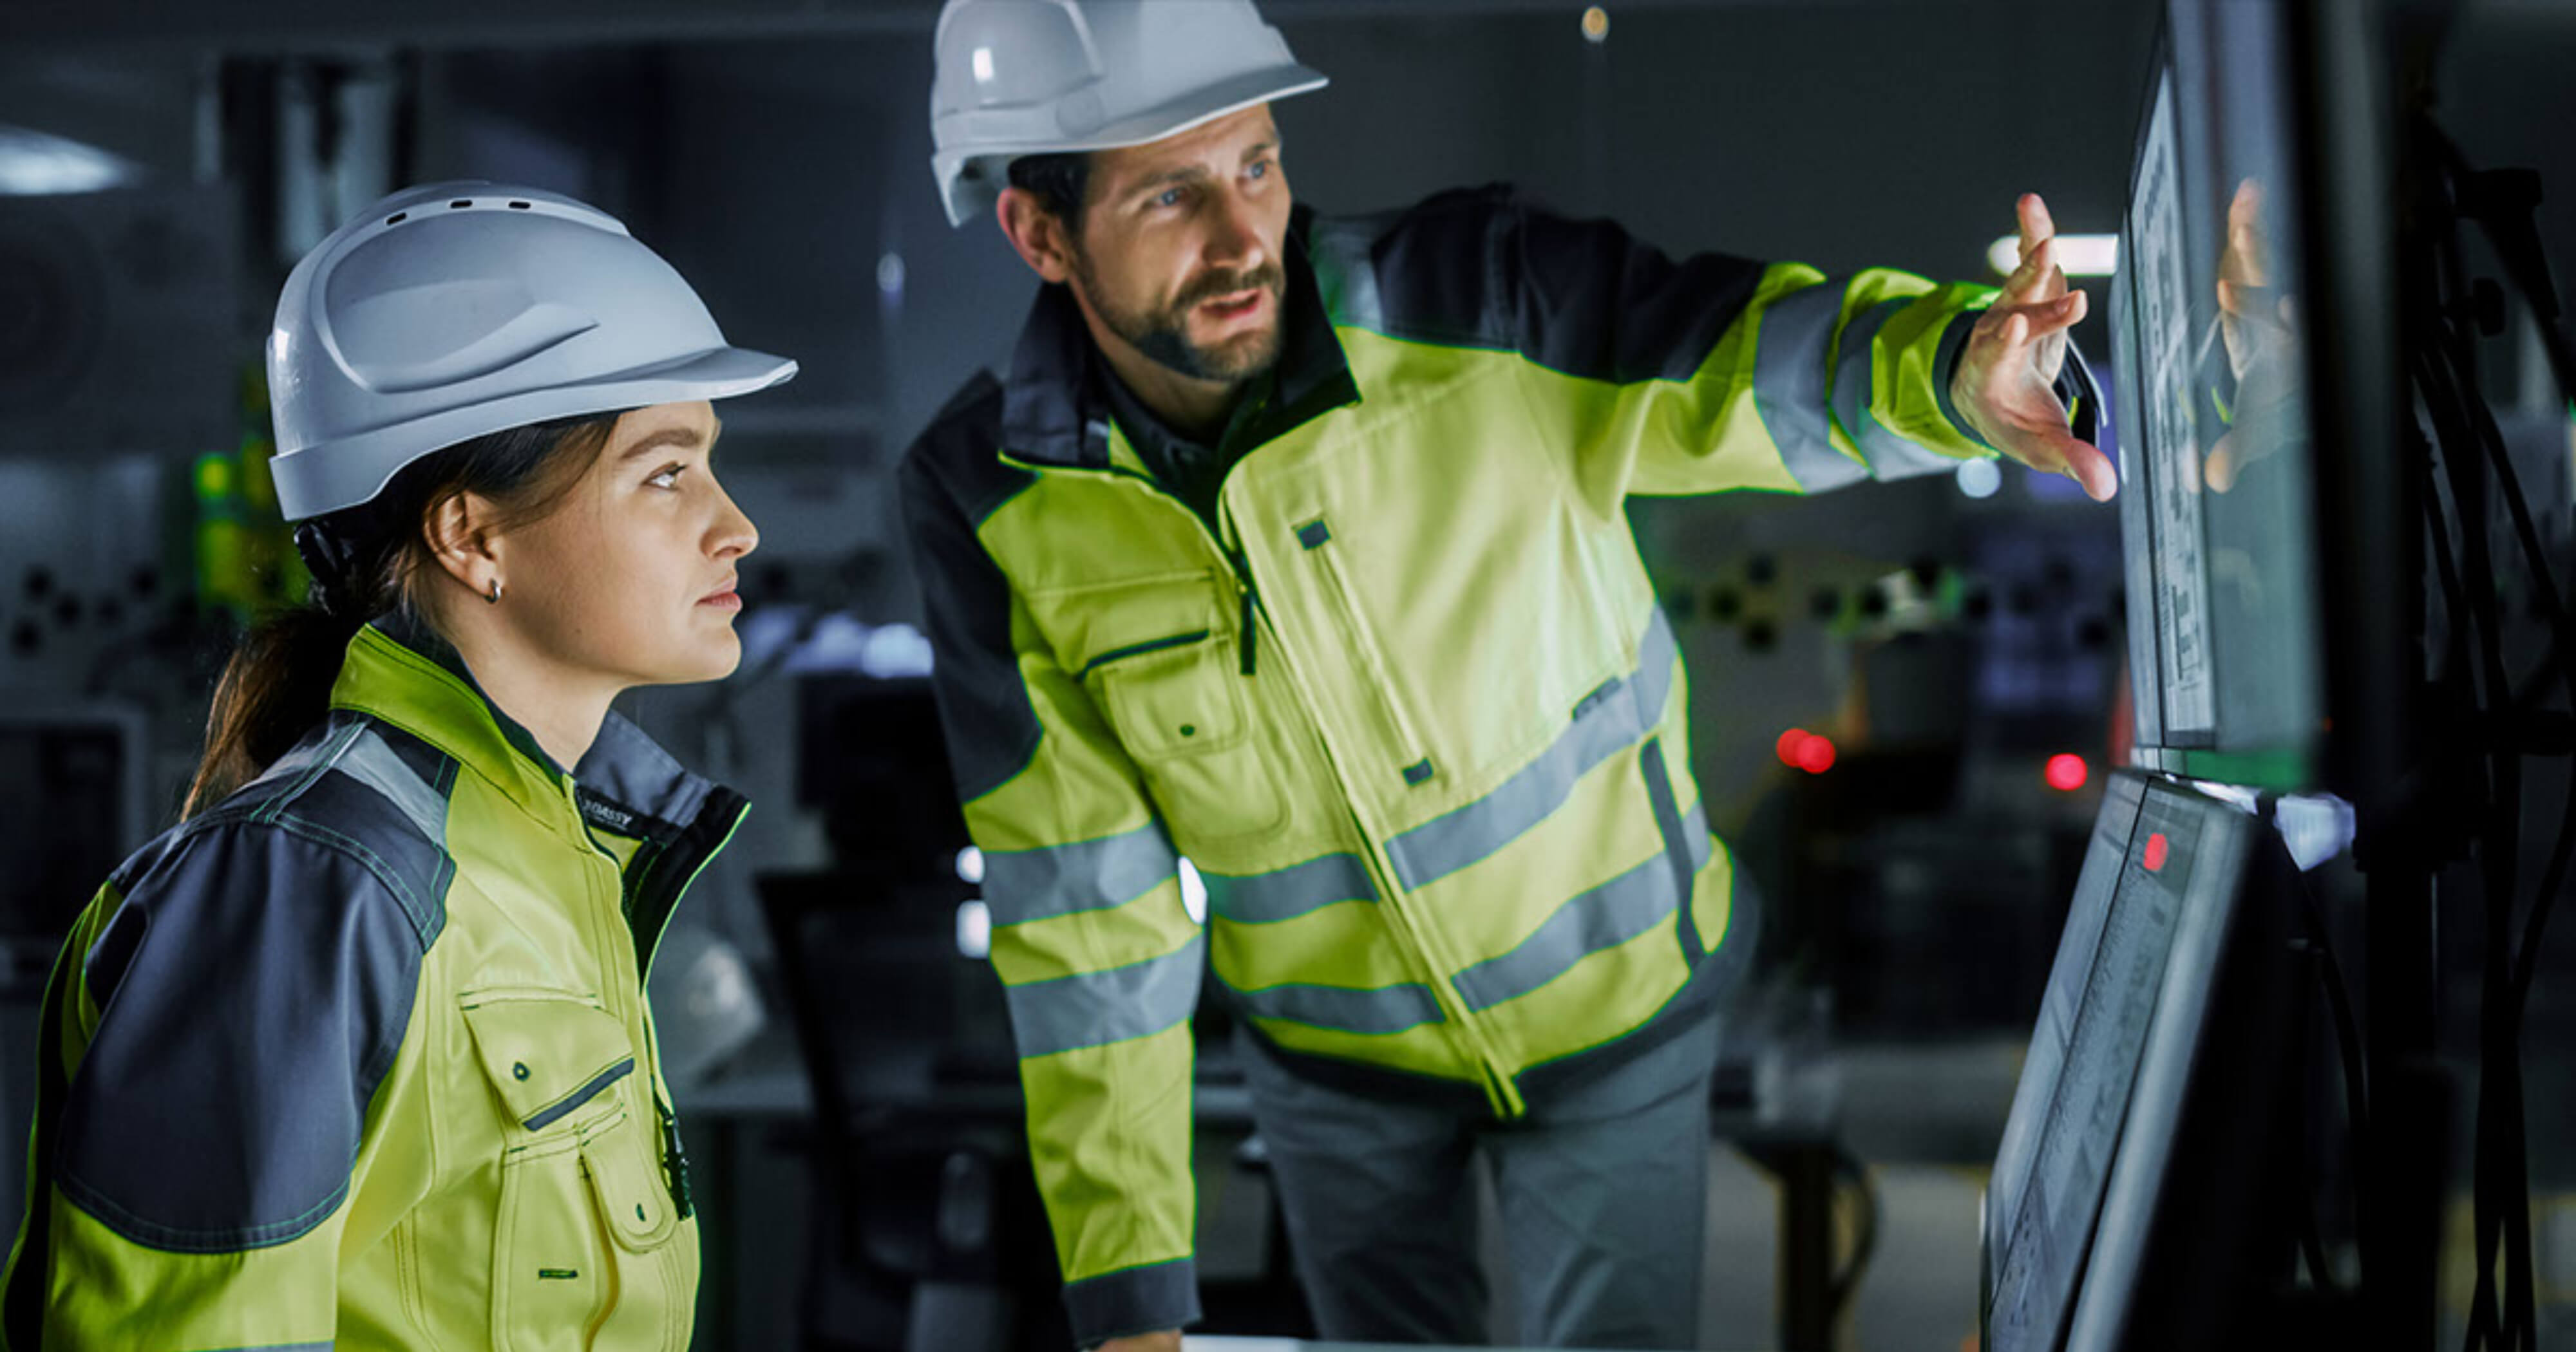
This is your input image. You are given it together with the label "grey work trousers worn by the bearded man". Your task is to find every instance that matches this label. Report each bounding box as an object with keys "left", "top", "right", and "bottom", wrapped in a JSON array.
[{"left": 1242, "top": 1017, "right": 1718, "bottom": 1349}]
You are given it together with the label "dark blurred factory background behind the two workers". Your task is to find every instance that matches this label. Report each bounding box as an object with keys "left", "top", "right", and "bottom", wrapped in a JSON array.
[{"left": 0, "top": 0, "right": 2576, "bottom": 1352}]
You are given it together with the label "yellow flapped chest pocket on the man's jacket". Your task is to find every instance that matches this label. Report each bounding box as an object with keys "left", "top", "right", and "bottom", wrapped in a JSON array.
[{"left": 1079, "top": 577, "right": 1285, "bottom": 840}]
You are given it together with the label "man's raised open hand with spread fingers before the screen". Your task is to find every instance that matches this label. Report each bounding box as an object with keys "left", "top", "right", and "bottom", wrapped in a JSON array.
[{"left": 1950, "top": 193, "right": 2120, "bottom": 502}]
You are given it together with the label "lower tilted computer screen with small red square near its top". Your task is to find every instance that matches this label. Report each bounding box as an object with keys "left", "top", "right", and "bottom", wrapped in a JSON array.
[{"left": 1984, "top": 773, "right": 2257, "bottom": 1352}]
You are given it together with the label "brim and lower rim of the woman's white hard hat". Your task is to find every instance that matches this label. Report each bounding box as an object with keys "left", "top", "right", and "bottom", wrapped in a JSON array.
[{"left": 270, "top": 348, "right": 796, "bottom": 520}]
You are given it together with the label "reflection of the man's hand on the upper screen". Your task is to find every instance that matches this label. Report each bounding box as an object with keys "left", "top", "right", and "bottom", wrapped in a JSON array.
[{"left": 2200, "top": 178, "right": 2300, "bottom": 492}]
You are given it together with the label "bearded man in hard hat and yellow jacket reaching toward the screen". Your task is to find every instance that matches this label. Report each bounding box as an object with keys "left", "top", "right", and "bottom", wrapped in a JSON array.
[{"left": 902, "top": 0, "right": 2112, "bottom": 1349}]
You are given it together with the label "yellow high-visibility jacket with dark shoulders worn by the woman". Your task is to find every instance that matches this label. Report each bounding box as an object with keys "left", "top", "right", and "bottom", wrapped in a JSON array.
[{"left": 0, "top": 621, "right": 744, "bottom": 1352}]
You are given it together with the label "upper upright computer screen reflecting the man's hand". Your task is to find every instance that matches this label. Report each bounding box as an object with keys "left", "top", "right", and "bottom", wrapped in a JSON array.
[{"left": 2112, "top": 0, "right": 2324, "bottom": 791}]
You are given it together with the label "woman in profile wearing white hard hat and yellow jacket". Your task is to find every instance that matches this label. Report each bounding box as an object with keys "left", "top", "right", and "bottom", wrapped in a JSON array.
[{"left": 0, "top": 183, "right": 796, "bottom": 1349}]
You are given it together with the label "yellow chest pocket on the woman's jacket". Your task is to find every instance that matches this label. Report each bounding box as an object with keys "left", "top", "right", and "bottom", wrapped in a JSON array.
[{"left": 464, "top": 989, "right": 685, "bottom": 1352}]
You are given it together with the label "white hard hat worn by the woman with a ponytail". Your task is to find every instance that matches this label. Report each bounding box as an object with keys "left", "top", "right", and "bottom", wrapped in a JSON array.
[{"left": 268, "top": 183, "right": 796, "bottom": 520}]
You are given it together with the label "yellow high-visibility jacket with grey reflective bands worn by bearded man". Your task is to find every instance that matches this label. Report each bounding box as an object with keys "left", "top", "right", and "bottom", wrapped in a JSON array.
[{"left": 902, "top": 188, "right": 2061, "bottom": 1344}]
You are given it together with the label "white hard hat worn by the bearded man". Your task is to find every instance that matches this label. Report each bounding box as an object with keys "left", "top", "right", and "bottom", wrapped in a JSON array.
[{"left": 930, "top": 0, "right": 1324, "bottom": 224}]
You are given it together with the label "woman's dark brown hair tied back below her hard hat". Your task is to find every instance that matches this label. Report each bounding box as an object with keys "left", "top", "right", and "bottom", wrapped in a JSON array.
[{"left": 185, "top": 412, "right": 618, "bottom": 816}]
